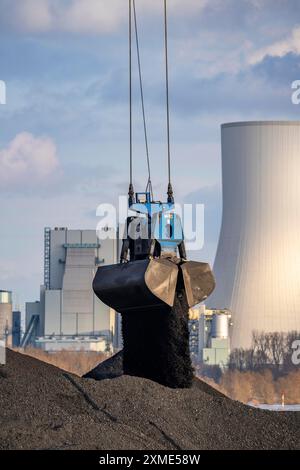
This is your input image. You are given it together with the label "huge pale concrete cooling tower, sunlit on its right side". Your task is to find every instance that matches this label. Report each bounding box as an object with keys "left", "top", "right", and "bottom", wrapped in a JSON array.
[{"left": 209, "top": 121, "right": 300, "bottom": 349}]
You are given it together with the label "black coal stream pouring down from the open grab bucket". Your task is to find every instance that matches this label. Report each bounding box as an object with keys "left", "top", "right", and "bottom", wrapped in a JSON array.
[{"left": 122, "top": 283, "right": 193, "bottom": 388}]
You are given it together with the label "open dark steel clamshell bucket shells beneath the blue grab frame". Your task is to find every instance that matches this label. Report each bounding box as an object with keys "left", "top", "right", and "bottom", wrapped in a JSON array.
[{"left": 93, "top": 258, "right": 215, "bottom": 313}]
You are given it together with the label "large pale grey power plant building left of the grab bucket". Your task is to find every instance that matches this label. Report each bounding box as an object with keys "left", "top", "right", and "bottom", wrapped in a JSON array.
[{"left": 26, "top": 228, "right": 117, "bottom": 350}]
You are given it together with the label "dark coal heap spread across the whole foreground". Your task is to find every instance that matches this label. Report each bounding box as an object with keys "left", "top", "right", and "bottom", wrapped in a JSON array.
[{"left": 0, "top": 351, "right": 300, "bottom": 450}]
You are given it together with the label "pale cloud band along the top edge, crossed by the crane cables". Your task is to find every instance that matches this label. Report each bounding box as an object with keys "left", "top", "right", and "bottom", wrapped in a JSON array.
[{"left": 0, "top": 0, "right": 209, "bottom": 34}]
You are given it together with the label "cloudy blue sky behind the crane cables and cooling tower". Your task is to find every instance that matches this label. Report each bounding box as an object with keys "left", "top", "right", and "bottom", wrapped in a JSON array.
[{"left": 0, "top": 0, "right": 300, "bottom": 305}]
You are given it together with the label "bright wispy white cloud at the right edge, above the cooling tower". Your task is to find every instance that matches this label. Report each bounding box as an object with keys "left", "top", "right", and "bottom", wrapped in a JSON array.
[{"left": 249, "top": 26, "right": 300, "bottom": 64}]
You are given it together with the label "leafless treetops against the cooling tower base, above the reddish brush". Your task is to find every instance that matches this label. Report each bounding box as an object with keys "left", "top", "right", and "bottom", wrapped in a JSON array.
[{"left": 228, "top": 331, "right": 300, "bottom": 372}]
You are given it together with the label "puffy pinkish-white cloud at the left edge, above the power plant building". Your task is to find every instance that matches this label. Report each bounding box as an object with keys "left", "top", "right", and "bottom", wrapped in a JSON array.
[{"left": 0, "top": 132, "right": 59, "bottom": 190}]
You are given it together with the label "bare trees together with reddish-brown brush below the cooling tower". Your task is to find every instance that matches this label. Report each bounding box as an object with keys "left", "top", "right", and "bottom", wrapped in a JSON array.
[{"left": 197, "top": 331, "right": 300, "bottom": 404}]
